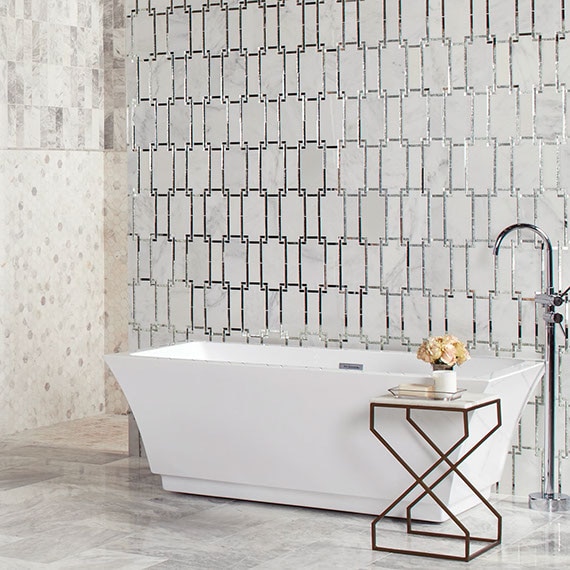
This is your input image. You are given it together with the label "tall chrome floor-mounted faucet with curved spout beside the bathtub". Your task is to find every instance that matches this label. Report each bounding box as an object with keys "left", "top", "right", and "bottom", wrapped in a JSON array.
[{"left": 493, "top": 223, "right": 570, "bottom": 512}]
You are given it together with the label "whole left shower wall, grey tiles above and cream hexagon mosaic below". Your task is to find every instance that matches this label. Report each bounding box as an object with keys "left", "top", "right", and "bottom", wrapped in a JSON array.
[{"left": 0, "top": 0, "right": 127, "bottom": 433}]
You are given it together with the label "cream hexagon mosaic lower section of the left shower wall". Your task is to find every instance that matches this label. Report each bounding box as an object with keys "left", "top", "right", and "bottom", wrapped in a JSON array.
[{"left": 0, "top": 150, "right": 105, "bottom": 433}]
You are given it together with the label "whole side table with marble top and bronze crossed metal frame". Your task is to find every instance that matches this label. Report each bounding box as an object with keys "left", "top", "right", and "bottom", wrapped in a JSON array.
[{"left": 370, "top": 393, "right": 496, "bottom": 562}]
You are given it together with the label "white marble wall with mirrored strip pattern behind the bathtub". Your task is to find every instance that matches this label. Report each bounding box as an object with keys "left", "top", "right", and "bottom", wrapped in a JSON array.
[{"left": 126, "top": 0, "right": 570, "bottom": 493}]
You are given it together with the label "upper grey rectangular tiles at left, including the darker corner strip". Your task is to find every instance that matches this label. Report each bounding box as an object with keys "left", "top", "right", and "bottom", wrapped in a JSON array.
[{"left": 0, "top": 0, "right": 126, "bottom": 152}]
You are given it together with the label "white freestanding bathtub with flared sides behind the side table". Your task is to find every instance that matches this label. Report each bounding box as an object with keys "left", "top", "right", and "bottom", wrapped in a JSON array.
[{"left": 106, "top": 342, "right": 544, "bottom": 521}]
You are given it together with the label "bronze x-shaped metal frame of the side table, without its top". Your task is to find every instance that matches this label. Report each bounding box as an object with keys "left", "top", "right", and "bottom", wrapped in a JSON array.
[{"left": 370, "top": 392, "right": 496, "bottom": 562}]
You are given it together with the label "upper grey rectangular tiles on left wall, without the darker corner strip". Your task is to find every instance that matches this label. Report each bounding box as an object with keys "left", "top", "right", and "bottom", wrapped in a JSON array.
[{"left": 0, "top": 0, "right": 104, "bottom": 149}]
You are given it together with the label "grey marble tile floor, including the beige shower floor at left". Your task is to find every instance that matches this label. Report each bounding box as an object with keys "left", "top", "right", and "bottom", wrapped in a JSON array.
[{"left": 0, "top": 416, "right": 570, "bottom": 570}]
